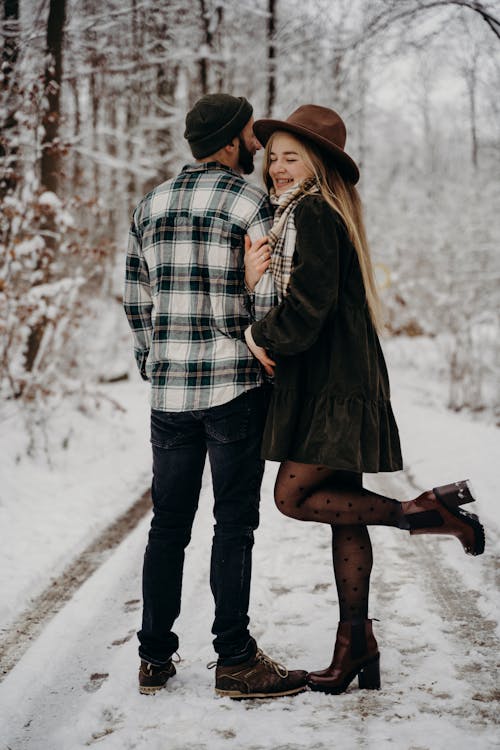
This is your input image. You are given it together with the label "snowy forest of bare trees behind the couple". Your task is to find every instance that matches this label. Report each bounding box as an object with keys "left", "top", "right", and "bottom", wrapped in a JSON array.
[{"left": 0, "top": 0, "right": 500, "bottom": 446}]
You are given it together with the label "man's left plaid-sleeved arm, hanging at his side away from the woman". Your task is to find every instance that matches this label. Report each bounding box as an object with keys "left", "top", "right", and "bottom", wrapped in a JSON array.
[{"left": 123, "top": 222, "right": 153, "bottom": 380}]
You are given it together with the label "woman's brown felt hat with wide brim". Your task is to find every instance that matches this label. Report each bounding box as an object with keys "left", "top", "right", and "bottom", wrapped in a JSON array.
[{"left": 253, "top": 104, "right": 359, "bottom": 184}]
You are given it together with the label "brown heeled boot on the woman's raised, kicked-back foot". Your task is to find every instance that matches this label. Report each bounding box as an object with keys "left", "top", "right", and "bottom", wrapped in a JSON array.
[{"left": 401, "top": 480, "right": 484, "bottom": 555}]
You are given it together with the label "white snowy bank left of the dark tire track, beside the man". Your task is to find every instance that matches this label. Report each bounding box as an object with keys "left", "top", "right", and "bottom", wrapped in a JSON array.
[{"left": 0, "top": 383, "right": 150, "bottom": 631}]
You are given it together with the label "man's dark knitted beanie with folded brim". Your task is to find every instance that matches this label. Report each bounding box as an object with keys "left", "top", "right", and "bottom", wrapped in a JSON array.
[{"left": 184, "top": 94, "right": 253, "bottom": 159}]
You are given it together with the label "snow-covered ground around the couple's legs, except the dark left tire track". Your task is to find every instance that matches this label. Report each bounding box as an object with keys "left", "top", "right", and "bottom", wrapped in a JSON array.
[{"left": 0, "top": 350, "right": 500, "bottom": 750}]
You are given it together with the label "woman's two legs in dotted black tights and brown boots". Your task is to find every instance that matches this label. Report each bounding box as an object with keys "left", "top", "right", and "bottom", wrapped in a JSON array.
[{"left": 275, "top": 468, "right": 484, "bottom": 693}]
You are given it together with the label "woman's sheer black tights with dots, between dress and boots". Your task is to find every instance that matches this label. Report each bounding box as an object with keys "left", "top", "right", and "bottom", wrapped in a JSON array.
[{"left": 274, "top": 461, "right": 404, "bottom": 621}]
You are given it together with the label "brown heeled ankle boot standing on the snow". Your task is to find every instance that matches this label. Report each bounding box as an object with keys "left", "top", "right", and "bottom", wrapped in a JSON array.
[{"left": 307, "top": 620, "right": 380, "bottom": 695}]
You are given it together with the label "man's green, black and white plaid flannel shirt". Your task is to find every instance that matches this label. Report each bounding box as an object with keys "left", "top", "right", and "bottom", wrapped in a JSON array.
[{"left": 124, "top": 162, "right": 276, "bottom": 412}]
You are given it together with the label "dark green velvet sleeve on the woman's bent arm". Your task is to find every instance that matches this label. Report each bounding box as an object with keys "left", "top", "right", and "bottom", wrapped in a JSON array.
[{"left": 252, "top": 196, "right": 340, "bottom": 355}]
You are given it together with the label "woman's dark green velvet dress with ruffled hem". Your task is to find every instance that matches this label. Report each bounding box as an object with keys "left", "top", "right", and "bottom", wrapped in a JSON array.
[{"left": 252, "top": 195, "right": 402, "bottom": 472}]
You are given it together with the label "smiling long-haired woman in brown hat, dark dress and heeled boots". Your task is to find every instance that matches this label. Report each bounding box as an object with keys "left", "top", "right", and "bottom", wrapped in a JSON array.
[{"left": 245, "top": 105, "right": 484, "bottom": 693}]
